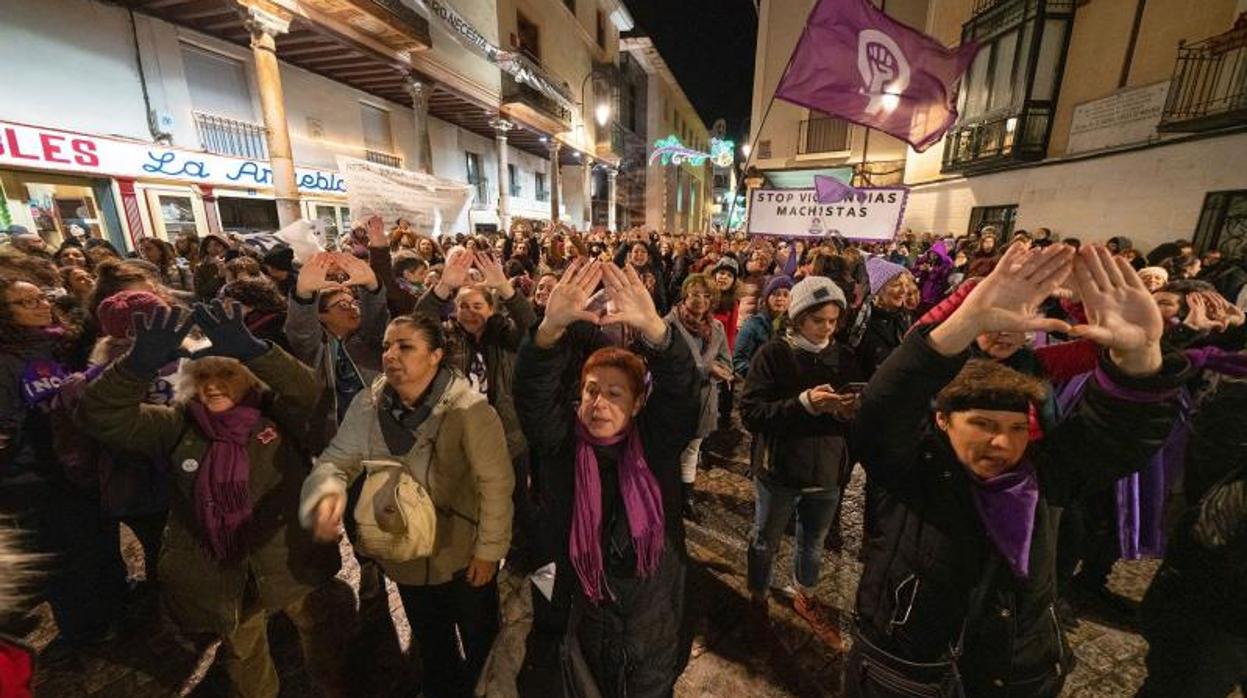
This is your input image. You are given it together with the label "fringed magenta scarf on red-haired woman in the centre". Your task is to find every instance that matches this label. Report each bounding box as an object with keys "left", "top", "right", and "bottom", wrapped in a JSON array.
[{"left": 569, "top": 419, "right": 666, "bottom": 603}]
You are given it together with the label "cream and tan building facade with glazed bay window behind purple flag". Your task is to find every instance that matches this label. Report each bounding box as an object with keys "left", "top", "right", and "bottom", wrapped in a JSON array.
[{"left": 754, "top": 0, "right": 1247, "bottom": 256}]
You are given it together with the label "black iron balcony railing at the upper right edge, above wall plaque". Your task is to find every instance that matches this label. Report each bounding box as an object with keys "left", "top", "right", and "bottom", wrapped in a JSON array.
[{"left": 1157, "top": 19, "right": 1247, "bottom": 131}]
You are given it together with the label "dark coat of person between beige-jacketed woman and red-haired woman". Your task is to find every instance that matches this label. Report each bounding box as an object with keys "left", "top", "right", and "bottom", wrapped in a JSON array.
[{"left": 414, "top": 288, "right": 537, "bottom": 459}]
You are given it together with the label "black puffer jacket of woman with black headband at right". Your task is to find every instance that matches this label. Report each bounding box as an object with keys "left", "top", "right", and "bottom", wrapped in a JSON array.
[{"left": 854, "top": 332, "right": 1190, "bottom": 698}]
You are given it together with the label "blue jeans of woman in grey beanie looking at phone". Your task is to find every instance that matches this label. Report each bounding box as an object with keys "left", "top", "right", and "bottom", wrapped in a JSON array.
[{"left": 748, "top": 479, "right": 840, "bottom": 592}]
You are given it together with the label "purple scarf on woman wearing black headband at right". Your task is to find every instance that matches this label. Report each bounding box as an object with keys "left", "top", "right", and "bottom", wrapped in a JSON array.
[{"left": 970, "top": 459, "right": 1039, "bottom": 577}]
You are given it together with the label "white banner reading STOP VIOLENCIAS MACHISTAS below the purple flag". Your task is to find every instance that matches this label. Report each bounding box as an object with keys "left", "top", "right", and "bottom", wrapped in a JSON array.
[{"left": 748, "top": 187, "right": 909, "bottom": 241}]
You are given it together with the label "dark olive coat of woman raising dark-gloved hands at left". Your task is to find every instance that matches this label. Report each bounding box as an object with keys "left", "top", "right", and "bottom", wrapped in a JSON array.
[{"left": 77, "top": 347, "right": 342, "bottom": 636}]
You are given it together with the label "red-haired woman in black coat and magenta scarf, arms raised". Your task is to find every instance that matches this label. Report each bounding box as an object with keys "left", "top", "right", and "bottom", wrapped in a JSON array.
[{"left": 515, "top": 262, "right": 701, "bottom": 698}]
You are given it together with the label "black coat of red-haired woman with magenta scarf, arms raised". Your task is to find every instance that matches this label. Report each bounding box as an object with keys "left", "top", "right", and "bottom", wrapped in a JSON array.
[{"left": 515, "top": 323, "right": 701, "bottom": 697}]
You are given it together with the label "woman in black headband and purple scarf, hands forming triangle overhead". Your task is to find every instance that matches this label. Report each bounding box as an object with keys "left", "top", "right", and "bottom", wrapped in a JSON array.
[{"left": 848, "top": 246, "right": 1188, "bottom": 698}]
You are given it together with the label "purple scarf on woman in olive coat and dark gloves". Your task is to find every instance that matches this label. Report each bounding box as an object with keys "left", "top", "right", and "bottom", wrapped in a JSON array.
[{"left": 187, "top": 394, "right": 259, "bottom": 561}]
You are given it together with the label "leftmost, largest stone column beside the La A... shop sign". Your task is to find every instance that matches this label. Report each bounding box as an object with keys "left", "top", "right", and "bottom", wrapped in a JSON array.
[{"left": 242, "top": 7, "right": 302, "bottom": 228}]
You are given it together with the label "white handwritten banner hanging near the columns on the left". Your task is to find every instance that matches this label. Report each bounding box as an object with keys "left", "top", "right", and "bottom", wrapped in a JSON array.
[{"left": 338, "top": 156, "right": 474, "bottom": 236}]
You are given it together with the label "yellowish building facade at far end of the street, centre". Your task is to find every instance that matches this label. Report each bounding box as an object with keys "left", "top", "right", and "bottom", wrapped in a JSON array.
[{"left": 621, "top": 35, "right": 713, "bottom": 234}]
